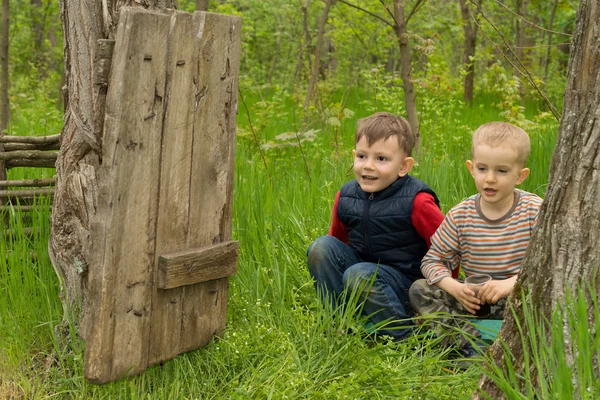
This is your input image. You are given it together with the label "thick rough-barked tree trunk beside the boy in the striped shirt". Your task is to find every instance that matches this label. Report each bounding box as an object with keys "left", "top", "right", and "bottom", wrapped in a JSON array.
[{"left": 473, "top": 0, "right": 600, "bottom": 399}]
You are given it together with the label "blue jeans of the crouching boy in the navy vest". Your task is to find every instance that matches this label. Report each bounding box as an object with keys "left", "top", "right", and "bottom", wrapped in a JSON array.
[{"left": 307, "top": 236, "right": 413, "bottom": 341}]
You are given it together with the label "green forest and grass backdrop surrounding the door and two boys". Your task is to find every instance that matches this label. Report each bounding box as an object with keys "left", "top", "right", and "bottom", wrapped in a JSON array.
[{"left": 0, "top": 0, "right": 584, "bottom": 399}]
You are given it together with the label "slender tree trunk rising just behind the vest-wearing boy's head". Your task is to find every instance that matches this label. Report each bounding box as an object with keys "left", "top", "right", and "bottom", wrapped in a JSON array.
[{"left": 394, "top": 0, "right": 421, "bottom": 154}]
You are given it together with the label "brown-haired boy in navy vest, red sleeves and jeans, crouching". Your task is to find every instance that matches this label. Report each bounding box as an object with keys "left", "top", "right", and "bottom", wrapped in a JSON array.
[{"left": 307, "top": 112, "right": 444, "bottom": 341}]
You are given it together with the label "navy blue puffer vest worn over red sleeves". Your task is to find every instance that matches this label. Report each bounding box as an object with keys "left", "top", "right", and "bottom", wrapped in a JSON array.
[{"left": 337, "top": 175, "right": 439, "bottom": 280}]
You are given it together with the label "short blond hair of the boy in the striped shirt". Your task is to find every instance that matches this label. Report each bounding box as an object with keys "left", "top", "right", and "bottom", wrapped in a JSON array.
[{"left": 471, "top": 122, "right": 531, "bottom": 166}]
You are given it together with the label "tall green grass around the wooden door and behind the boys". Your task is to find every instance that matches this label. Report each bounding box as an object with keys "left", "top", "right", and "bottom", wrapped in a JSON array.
[{"left": 0, "top": 89, "right": 596, "bottom": 399}]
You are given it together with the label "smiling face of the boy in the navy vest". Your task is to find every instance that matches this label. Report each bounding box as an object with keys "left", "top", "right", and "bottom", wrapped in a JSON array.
[{"left": 352, "top": 136, "right": 414, "bottom": 193}]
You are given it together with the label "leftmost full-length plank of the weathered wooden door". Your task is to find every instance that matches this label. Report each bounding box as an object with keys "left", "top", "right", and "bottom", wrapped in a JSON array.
[{"left": 84, "top": 7, "right": 170, "bottom": 383}]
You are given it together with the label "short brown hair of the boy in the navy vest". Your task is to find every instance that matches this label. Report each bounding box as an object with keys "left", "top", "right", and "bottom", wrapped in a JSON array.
[{"left": 354, "top": 112, "right": 415, "bottom": 156}]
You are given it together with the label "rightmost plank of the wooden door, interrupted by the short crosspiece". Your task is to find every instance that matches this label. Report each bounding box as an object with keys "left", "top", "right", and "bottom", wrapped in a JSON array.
[{"left": 181, "top": 12, "right": 241, "bottom": 351}]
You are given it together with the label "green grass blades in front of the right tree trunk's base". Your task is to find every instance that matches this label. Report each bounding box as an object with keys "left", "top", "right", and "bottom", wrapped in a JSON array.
[{"left": 487, "top": 280, "right": 600, "bottom": 400}]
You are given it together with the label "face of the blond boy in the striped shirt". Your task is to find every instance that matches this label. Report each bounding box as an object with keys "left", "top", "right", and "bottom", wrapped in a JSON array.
[{"left": 467, "top": 143, "right": 529, "bottom": 219}]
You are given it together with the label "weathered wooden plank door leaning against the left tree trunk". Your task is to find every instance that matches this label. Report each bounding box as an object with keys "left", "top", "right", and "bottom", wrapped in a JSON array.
[{"left": 83, "top": 8, "right": 241, "bottom": 383}]
